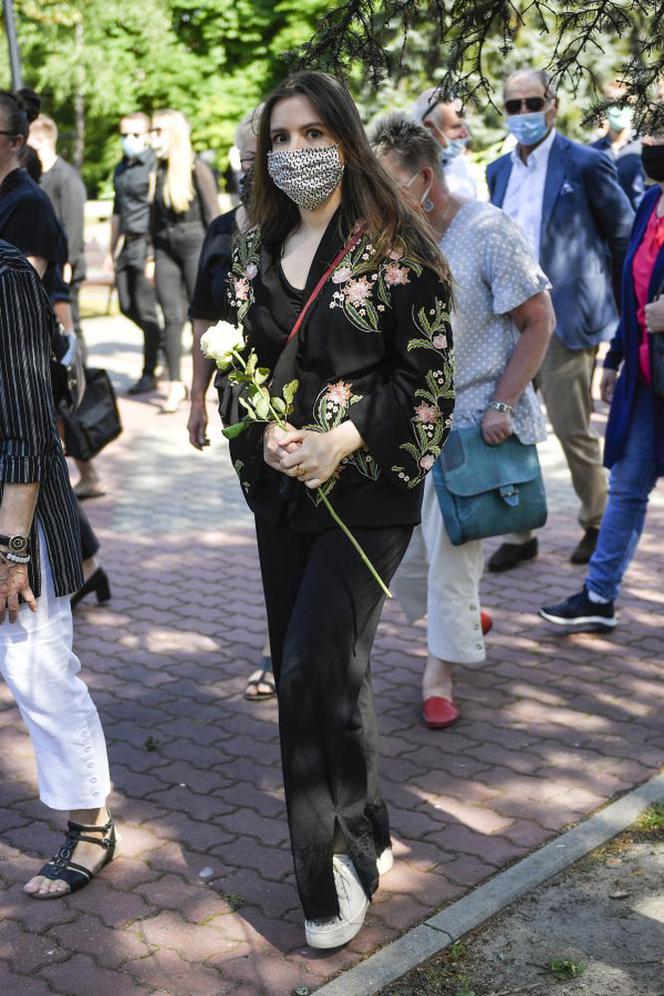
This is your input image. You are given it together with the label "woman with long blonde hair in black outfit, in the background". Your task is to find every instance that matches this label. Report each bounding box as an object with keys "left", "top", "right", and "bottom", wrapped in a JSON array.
[{"left": 150, "top": 110, "right": 219, "bottom": 413}]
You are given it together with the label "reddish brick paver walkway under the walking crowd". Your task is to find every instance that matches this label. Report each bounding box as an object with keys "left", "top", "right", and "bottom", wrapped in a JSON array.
[{"left": 0, "top": 319, "right": 664, "bottom": 996}]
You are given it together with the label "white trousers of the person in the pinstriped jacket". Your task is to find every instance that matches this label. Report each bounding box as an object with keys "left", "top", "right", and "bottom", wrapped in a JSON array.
[{"left": 0, "top": 530, "right": 111, "bottom": 810}]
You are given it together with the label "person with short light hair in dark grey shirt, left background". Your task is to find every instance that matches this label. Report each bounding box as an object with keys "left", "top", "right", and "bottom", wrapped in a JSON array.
[{"left": 29, "top": 114, "right": 86, "bottom": 339}]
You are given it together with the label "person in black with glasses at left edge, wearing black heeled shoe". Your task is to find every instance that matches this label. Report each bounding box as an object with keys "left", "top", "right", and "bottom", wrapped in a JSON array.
[{"left": 0, "top": 90, "right": 110, "bottom": 605}]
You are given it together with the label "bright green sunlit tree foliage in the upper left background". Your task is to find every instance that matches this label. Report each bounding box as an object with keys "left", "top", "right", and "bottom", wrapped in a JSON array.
[{"left": 0, "top": 0, "right": 328, "bottom": 193}]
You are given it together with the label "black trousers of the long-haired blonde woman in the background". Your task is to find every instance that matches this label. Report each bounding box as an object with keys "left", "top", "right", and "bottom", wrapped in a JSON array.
[{"left": 154, "top": 225, "right": 205, "bottom": 380}]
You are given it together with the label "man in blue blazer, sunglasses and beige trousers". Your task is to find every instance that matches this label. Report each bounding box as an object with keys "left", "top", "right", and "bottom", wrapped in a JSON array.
[{"left": 487, "top": 69, "right": 634, "bottom": 571}]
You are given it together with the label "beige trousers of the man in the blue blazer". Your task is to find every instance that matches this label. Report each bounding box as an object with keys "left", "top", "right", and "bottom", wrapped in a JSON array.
[{"left": 505, "top": 335, "right": 607, "bottom": 543}]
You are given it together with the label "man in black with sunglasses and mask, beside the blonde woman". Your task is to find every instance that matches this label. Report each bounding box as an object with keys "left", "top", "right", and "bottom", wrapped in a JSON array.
[{"left": 105, "top": 111, "right": 161, "bottom": 394}]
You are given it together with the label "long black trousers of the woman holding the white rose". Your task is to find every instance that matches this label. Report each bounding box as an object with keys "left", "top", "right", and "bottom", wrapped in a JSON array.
[{"left": 256, "top": 518, "right": 412, "bottom": 920}]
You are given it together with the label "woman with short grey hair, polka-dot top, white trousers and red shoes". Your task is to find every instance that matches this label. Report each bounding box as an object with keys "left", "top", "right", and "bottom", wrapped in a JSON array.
[{"left": 371, "top": 115, "right": 554, "bottom": 729}]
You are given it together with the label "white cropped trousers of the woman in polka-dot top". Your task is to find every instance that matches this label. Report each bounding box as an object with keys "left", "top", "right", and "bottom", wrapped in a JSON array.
[{"left": 392, "top": 474, "right": 486, "bottom": 665}]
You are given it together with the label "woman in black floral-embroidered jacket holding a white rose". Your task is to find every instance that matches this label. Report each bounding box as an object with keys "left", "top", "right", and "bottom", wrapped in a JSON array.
[{"left": 217, "top": 73, "right": 453, "bottom": 948}]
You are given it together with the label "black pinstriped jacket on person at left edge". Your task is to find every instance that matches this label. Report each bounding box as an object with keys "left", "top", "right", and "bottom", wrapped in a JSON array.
[{"left": 0, "top": 240, "right": 83, "bottom": 596}]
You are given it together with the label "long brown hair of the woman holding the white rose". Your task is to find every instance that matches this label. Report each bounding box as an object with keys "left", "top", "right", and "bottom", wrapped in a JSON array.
[{"left": 250, "top": 71, "right": 452, "bottom": 289}]
